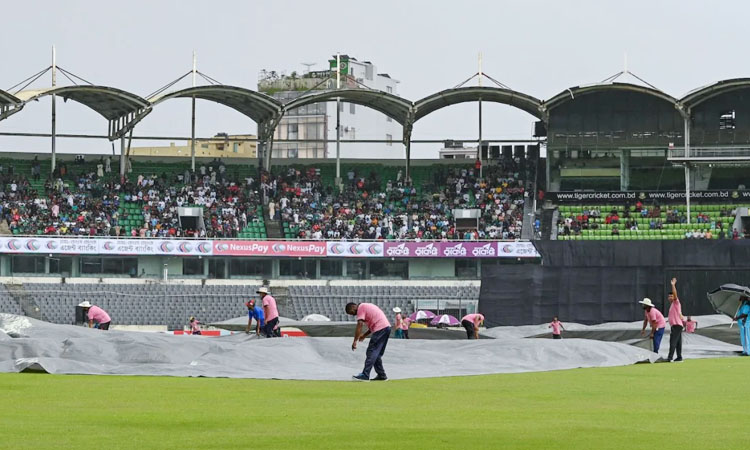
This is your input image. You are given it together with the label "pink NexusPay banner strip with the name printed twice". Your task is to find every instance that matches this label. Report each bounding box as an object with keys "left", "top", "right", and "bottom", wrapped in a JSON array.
[{"left": 213, "top": 241, "right": 326, "bottom": 257}]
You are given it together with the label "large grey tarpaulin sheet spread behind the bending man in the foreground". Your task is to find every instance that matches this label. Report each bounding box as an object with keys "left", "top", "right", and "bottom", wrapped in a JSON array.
[{"left": 0, "top": 314, "right": 656, "bottom": 380}]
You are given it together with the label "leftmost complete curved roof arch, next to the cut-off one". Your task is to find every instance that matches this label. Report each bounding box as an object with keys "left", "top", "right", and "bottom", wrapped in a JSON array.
[{"left": 17, "top": 85, "right": 151, "bottom": 120}]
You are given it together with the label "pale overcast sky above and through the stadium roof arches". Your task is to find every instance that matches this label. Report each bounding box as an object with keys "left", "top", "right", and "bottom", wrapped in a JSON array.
[{"left": 0, "top": 0, "right": 750, "bottom": 157}]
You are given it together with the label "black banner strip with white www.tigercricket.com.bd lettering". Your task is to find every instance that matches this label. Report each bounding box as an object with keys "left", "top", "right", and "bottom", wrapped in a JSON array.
[{"left": 544, "top": 190, "right": 750, "bottom": 204}]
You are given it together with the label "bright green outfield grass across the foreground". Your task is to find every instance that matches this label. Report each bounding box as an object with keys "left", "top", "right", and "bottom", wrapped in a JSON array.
[{"left": 0, "top": 358, "right": 750, "bottom": 450}]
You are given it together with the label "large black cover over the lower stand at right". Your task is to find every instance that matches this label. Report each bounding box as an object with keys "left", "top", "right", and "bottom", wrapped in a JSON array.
[{"left": 479, "top": 240, "right": 750, "bottom": 326}]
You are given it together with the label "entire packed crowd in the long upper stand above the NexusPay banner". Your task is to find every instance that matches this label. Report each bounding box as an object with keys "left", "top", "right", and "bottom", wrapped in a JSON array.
[{"left": 0, "top": 158, "right": 525, "bottom": 240}]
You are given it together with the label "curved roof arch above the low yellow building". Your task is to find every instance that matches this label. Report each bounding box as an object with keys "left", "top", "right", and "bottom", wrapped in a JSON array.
[{"left": 151, "top": 84, "right": 282, "bottom": 123}]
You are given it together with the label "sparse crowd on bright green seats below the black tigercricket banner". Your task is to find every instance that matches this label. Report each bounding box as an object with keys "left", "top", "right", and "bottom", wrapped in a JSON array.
[{"left": 557, "top": 201, "right": 748, "bottom": 239}]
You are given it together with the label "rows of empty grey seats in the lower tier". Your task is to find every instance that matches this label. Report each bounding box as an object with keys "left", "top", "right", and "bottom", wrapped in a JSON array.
[{"left": 0, "top": 283, "right": 479, "bottom": 329}]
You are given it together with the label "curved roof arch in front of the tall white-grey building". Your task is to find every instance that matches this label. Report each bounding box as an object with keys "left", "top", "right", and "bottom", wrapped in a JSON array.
[{"left": 284, "top": 89, "right": 412, "bottom": 125}]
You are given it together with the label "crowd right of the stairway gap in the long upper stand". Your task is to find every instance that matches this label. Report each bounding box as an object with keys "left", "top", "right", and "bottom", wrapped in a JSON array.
[{"left": 270, "top": 160, "right": 525, "bottom": 240}]
